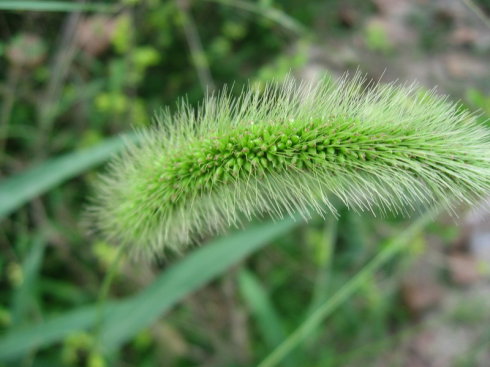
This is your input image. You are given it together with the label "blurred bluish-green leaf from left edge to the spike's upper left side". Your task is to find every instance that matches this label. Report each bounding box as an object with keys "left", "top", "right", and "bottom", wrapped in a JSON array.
[{"left": 0, "top": 135, "right": 134, "bottom": 219}]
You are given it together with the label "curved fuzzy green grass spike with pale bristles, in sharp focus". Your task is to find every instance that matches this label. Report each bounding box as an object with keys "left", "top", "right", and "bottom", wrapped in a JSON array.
[{"left": 91, "top": 74, "right": 490, "bottom": 256}]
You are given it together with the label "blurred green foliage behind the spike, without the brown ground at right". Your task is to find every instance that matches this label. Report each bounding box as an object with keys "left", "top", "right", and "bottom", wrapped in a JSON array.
[{"left": 0, "top": 0, "right": 490, "bottom": 367}]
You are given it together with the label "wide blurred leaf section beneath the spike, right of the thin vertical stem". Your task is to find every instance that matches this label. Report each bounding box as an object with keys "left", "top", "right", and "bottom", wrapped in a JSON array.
[{"left": 101, "top": 218, "right": 299, "bottom": 349}]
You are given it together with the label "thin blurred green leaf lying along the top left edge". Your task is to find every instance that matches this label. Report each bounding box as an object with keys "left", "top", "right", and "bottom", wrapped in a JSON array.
[{"left": 0, "top": 0, "right": 116, "bottom": 12}]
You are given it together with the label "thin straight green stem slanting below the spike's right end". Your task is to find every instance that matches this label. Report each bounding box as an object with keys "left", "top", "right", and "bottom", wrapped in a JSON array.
[{"left": 258, "top": 207, "right": 442, "bottom": 367}]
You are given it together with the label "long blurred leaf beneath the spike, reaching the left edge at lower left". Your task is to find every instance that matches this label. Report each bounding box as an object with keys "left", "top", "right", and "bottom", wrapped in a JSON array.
[{"left": 0, "top": 218, "right": 300, "bottom": 360}]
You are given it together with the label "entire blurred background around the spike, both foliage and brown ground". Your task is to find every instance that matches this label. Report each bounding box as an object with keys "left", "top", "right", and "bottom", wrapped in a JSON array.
[{"left": 0, "top": 0, "right": 490, "bottom": 367}]
